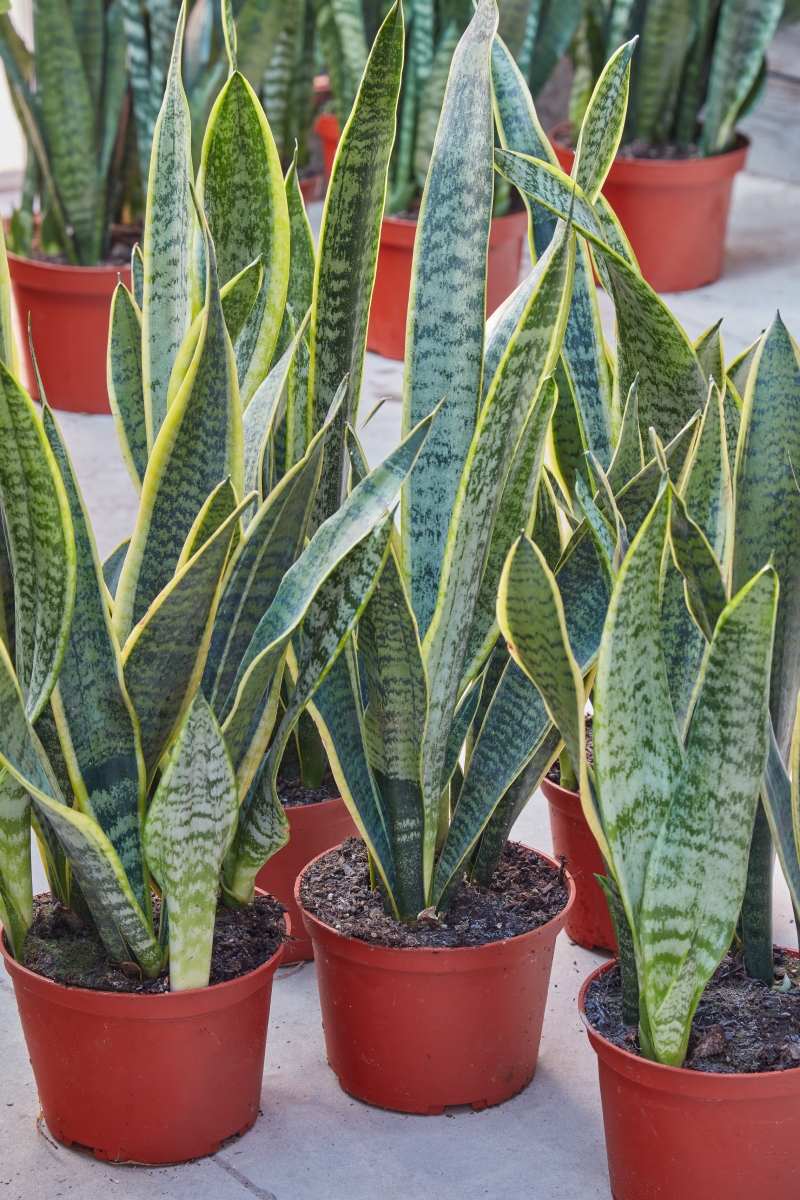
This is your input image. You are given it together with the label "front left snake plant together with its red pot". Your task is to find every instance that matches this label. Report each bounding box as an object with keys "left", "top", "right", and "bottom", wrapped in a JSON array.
[{"left": 0, "top": 2, "right": 429, "bottom": 1163}]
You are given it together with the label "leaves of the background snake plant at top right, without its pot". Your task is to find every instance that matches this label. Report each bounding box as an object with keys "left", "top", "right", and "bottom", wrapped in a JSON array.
[{"left": 570, "top": 0, "right": 784, "bottom": 156}]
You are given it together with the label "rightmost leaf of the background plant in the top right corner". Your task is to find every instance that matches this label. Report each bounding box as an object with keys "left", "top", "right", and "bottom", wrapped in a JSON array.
[{"left": 700, "top": 0, "right": 783, "bottom": 155}]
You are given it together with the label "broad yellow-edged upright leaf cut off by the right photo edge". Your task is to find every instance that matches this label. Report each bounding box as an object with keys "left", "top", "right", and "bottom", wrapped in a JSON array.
[{"left": 733, "top": 314, "right": 800, "bottom": 761}]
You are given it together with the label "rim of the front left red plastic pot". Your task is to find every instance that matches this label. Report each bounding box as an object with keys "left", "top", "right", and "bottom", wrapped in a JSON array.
[{"left": 0, "top": 888, "right": 291, "bottom": 1020}]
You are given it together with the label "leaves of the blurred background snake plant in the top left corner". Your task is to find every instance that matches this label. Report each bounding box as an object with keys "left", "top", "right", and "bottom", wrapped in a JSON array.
[{"left": 0, "top": 0, "right": 130, "bottom": 266}]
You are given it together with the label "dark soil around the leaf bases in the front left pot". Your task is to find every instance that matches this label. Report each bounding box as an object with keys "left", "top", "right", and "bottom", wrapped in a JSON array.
[{"left": 16, "top": 892, "right": 285, "bottom": 995}]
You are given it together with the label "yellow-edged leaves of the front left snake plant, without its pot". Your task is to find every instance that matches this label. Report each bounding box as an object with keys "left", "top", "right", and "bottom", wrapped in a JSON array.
[{"left": 0, "top": 10, "right": 431, "bottom": 990}]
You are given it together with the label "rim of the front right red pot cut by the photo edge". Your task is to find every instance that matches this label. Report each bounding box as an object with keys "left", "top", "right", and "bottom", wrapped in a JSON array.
[{"left": 578, "top": 947, "right": 800, "bottom": 1100}]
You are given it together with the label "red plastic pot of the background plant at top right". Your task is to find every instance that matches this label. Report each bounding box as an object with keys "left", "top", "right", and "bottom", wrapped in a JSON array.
[{"left": 551, "top": 125, "right": 750, "bottom": 292}]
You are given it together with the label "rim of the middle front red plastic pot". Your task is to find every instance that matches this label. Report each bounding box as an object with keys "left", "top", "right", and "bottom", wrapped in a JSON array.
[{"left": 294, "top": 842, "right": 577, "bottom": 971}]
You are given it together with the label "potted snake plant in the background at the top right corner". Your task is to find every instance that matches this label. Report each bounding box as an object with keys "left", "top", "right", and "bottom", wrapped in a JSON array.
[{"left": 552, "top": 0, "right": 784, "bottom": 292}]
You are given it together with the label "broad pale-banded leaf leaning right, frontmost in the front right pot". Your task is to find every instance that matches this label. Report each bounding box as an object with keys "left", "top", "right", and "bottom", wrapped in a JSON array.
[{"left": 638, "top": 566, "right": 778, "bottom": 1067}]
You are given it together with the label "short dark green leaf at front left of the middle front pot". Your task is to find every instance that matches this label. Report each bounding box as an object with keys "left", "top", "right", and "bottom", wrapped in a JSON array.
[{"left": 359, "top": 554, "right": 429, "bottom": 919}]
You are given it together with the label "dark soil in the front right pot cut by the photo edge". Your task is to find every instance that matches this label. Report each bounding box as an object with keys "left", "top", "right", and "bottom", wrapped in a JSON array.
[{"left": 587, "top": 947, "right": 800, "bottom": 1075}]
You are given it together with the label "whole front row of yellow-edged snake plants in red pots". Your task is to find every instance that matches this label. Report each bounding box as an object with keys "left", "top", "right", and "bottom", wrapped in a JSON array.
[{"left": 0, "top": 0, "right": 800, "bottom": 1200}]
